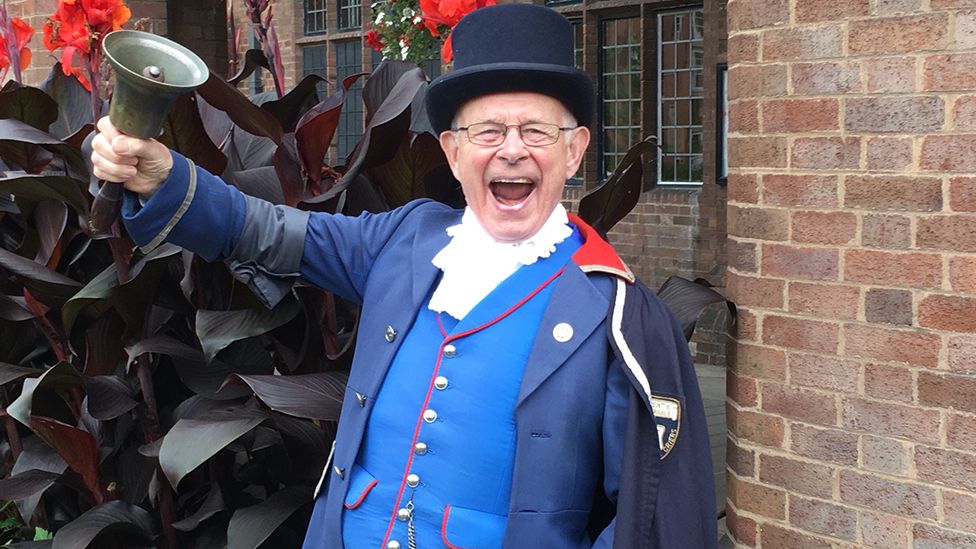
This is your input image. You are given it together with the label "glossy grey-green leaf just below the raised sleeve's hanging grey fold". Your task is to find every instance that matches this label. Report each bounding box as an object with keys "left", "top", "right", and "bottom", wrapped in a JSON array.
[{"left": 196, "top": 299, "right": 301, "bottom": 362}]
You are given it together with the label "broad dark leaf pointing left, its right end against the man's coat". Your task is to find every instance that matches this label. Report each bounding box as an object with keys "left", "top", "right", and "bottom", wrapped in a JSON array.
[{"left": 228, "top": 372, "right": 349, "bottom": 421}]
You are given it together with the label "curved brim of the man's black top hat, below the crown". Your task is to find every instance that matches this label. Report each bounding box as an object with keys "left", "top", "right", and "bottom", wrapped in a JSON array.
[{"left": 427, "top": 63, "right": 594, "bottom": 133}]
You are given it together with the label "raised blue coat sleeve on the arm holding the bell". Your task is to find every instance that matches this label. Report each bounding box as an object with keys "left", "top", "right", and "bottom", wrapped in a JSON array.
[{"left": 122, "top": 152, "right": 438, "bottom": 307}]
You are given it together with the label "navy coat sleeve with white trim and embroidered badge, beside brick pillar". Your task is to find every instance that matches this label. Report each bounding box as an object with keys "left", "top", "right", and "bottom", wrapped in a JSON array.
[{"left": 610, "top": 282, "right": 718, "bottom": 549}]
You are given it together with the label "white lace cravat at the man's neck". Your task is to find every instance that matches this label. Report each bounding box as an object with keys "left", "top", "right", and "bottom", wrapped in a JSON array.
[{"left": 429, "top": 204, "right": 573, "bottom": 320}]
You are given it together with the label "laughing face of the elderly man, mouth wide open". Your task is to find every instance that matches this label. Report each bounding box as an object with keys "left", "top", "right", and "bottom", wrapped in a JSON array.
[{"left": 440, "top": 92, "right": 590, "bottom": 242}]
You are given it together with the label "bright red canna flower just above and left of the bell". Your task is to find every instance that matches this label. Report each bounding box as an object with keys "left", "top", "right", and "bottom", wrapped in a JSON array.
[{"left": 44, "top": 0, "right": 132, "bottom": 90}]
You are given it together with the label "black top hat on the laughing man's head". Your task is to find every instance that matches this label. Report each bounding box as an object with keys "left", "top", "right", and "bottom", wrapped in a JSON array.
[{"left": 427, "top": 4, "right": 594, "bottom": 133}]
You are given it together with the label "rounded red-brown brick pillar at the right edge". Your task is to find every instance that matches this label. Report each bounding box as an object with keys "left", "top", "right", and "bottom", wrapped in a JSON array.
[{"left": 727, "top": 0, "right": 976, "bottom": 549}]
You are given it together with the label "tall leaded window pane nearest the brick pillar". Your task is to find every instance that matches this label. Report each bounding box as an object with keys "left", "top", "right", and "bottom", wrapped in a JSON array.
[{"left": 657, "top": 9, "right": 704, "bottom": 183}]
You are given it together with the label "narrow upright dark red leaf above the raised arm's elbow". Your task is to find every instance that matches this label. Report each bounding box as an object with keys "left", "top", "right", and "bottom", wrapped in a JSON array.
[{"left": 295, "top": 73, "right": 366, "bottom": 184}]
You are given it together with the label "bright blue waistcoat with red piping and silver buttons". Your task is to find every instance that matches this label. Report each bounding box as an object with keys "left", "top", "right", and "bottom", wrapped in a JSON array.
[{"left": 332, "top": 232, "right": 582, "bottom": 549}]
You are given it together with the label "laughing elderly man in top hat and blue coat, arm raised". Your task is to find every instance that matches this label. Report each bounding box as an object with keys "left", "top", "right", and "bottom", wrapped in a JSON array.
[{"left": 92, "top": 4, "right": 717, "bottom": 549}]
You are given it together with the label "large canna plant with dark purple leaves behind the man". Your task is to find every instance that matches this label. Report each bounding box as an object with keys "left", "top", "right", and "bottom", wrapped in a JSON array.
[{"left": 0, "top": 5, "right": 728, "bottom": 549}]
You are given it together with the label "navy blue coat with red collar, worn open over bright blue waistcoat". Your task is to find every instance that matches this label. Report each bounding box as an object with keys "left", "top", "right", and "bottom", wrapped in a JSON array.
[{"left": 124, "top": 154, "right": 717, "bottom": 549}]
